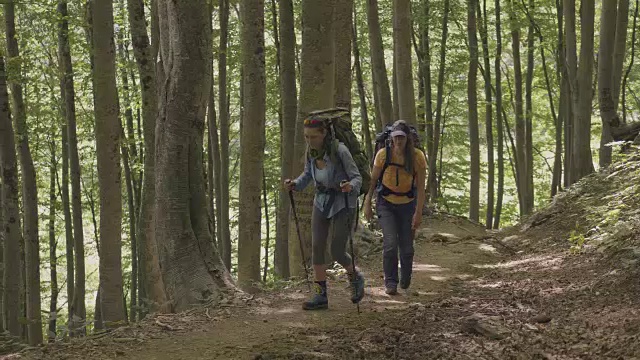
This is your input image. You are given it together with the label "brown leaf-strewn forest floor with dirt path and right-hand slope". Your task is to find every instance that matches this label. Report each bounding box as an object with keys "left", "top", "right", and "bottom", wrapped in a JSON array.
[{"left": 14, "top": 151, "right": 640, "bottom": 360}]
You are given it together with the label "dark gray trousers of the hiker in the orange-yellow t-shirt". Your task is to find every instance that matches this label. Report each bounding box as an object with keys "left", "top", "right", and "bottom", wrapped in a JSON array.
[{"left": 376, "top": 196, "right": 416, "bottom": 287}]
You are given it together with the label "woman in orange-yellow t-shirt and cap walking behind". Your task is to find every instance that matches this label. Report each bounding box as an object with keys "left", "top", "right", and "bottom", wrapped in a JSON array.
[{"left": 364, "top": 120, "right": 427, "bottom": 295}]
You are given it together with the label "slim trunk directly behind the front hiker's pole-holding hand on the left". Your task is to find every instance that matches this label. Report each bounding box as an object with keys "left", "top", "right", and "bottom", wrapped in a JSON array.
[{"left": 274, "top": 0, "right": 298, "bottom": 279}]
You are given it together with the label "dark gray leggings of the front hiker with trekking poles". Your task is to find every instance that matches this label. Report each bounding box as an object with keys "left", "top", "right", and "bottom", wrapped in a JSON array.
[{"left": 311, "top": 206, "right": 355, "bottom": 267}]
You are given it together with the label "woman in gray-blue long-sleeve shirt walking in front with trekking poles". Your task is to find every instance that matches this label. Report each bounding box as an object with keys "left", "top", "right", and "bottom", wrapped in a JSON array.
[{"left": 284, "top": 117, "right": 364, "bottom": 310}]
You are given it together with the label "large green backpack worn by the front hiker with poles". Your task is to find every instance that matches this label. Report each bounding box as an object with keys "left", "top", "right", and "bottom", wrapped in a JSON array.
[{"left": 307, "top": 108, "right": 371, "bottom": 195}]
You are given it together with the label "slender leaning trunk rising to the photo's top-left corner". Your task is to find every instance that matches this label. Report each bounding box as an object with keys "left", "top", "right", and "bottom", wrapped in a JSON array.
[{"left": 4, "top": 0, "right": 42, "bottom": 345}]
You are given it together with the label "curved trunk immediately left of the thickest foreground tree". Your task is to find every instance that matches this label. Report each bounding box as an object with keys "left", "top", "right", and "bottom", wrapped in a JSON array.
[{"left": 127, "top": 0, "right": 169, "bottom": 312}]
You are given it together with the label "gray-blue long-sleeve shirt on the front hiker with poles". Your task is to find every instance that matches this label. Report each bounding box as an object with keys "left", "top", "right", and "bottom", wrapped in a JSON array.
[{"left": 294, "top": 143, "right": 362, "bottom": 218}]
